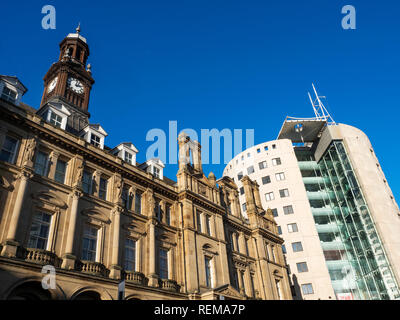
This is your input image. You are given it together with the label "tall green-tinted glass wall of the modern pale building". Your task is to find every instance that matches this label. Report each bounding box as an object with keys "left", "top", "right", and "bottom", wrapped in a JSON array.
[{"left": 296, "top": 141, "right": 400, "bottom": 300}]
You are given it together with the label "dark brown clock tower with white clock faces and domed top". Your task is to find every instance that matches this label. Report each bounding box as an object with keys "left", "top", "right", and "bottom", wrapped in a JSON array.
[{"left": 40, "top": 26, "right": 94, "bottom": 133}]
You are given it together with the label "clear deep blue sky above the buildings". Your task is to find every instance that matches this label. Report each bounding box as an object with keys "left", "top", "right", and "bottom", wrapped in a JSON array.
[{"left": 0, "top": 0, "right": 400, "bottom": 200}]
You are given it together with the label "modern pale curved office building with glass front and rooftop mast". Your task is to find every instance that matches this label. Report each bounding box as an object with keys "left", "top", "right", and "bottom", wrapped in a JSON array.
[{"left": 224, "top": 93, "right": 400, "bottom": 300}]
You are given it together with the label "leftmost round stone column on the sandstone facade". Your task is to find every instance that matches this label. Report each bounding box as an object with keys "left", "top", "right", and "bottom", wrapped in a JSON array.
[{"left": 1, "top": 168, "right": 33, "bottom": 257}]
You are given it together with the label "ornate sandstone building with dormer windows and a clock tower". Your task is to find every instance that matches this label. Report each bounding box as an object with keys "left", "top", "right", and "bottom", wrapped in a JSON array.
[{"left": 0, "top": 28, "right": 291, "bottom": 300}]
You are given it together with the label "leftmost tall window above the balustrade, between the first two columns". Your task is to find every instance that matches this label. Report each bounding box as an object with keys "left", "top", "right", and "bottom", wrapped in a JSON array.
[{"left": 28, "top": 212, "right": 51, "bottom": 250}]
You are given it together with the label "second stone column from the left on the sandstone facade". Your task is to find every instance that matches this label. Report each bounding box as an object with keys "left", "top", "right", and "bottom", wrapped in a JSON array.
[{"left": 61, "top": 189, "right": 82, "bottom": 270}]
